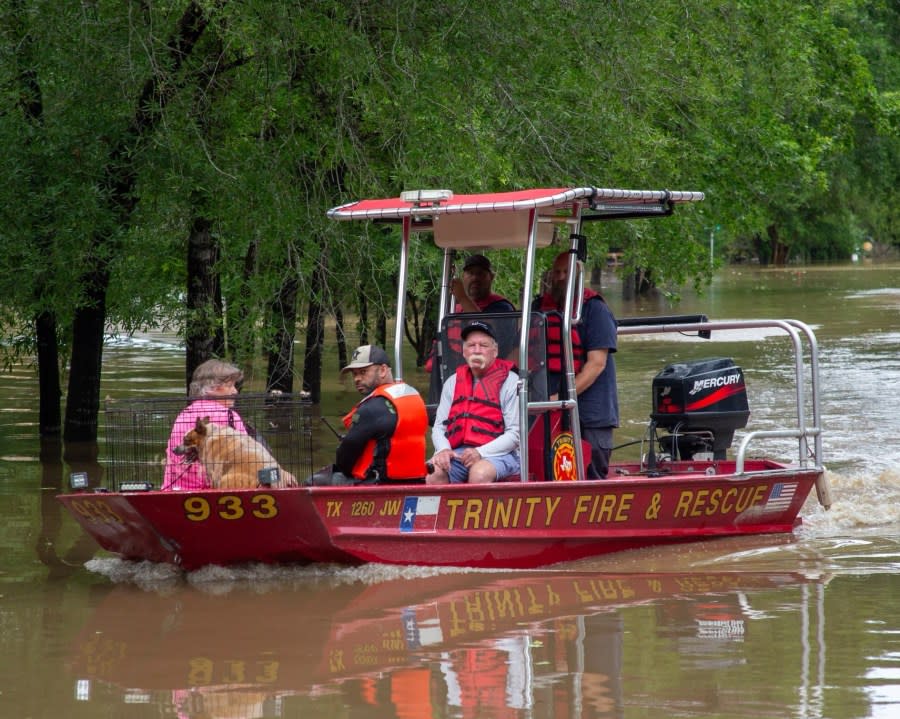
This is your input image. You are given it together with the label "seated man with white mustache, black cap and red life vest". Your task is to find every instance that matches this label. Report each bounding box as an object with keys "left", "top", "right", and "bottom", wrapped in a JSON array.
[{"left": 426, "top": 320, "right": 519, "bottom": 484}]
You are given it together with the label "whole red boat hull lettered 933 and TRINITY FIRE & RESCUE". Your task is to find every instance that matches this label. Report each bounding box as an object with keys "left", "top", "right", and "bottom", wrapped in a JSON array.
[{"left": 59, "top": 460, "right": 821, "bottom": 570}]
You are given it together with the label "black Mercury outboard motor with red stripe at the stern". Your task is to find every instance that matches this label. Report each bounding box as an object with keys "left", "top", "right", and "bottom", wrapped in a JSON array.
[{"left": 650, "top": 357, "right": 750, "bottom": 459}]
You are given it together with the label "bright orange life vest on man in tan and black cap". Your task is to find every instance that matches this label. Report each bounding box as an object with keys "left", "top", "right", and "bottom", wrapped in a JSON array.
[{"left": 343, "top": 382, "right": 428, "bottom": 480}]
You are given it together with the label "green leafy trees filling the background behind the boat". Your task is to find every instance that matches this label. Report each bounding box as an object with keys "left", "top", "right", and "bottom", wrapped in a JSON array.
[{"left": 0, "top": 0, "right": 900, "bottom": 436}]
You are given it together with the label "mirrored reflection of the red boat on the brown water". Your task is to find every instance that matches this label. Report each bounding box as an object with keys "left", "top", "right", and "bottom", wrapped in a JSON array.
[{"left": 70, "top": 544, "right": 827, "bottom": 717}]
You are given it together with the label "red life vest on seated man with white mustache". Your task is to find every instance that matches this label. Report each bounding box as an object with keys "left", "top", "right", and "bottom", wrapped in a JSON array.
[{"left": 445, "top": 358, "right": 513, "bottom": 449}]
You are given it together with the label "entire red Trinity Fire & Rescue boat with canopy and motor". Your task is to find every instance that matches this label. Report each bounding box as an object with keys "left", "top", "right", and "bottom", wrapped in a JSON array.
[{"left": 59, "top": 187, "right": 830, "bottom": 570}]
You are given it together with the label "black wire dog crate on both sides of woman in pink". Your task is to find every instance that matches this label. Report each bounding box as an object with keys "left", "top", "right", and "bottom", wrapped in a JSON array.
[{"left": 101, "top": 393, "right": 313, "bottom": 491}]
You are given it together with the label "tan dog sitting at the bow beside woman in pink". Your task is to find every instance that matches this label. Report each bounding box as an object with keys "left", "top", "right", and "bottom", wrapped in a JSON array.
[{"left": 176, "top": 417, "right": 297, "bottom": 489}]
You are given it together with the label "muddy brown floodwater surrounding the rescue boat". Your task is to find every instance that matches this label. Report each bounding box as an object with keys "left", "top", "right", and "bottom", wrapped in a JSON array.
[{"left": 0, "top": 266, "right": 900, "bottom": 719}]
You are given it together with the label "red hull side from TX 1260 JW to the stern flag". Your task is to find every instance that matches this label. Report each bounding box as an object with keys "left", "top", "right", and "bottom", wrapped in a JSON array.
[{"left": 322, "top": 472, "right": 816, "bottom": 568}]
